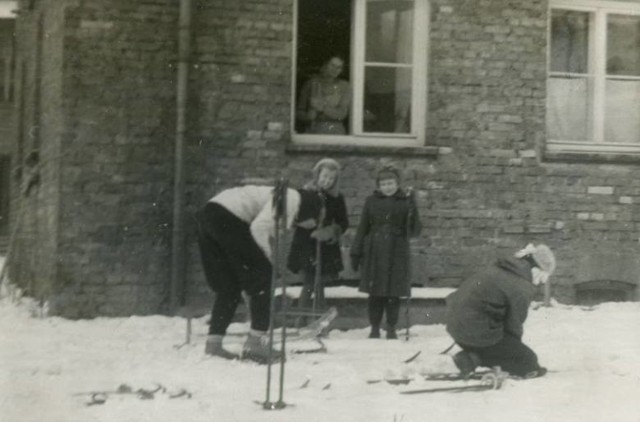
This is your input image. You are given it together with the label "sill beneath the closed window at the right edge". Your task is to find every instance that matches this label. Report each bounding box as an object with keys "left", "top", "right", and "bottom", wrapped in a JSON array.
[{"left": 544, "top": 141, "right": 640, "bottom": 164}]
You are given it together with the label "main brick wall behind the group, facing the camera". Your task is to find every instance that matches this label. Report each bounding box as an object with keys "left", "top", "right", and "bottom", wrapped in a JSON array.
[{"left": 12, "top": 0, "right": 640, "bottom": 316}]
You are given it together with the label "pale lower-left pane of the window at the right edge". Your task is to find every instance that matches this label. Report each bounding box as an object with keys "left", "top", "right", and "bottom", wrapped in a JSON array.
[{"left": 547, "top": 77, "right": 591, "bottom": 141}]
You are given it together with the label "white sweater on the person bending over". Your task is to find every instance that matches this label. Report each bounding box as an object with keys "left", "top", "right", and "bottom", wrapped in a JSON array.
[{"left": 209, "top": 185, "right": 300, "bottom": 260}]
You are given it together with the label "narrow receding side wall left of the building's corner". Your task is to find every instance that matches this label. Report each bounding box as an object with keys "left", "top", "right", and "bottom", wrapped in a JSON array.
[{"left": 10, "top": 2, "right": 63, "bottom": 300}]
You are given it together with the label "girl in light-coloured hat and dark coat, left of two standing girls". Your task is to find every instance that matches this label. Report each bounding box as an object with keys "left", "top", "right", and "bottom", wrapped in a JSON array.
[{"left": 287, "top": 158, "right": 349, "bottom": 309}]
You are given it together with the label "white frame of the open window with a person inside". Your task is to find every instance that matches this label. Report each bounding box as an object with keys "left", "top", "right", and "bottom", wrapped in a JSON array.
[{"left": 291, "top": 0, "right": 429, "bottom": 147}]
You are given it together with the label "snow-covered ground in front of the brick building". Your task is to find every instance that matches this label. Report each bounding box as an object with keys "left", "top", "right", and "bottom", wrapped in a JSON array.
[{"left": 0, "top": 290, "right": 640, "bottom": 422}]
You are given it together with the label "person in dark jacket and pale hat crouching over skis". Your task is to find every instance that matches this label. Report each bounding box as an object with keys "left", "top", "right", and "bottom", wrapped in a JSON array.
[{"left": 446, "top": 244, "right": 556, "bottom": 378}]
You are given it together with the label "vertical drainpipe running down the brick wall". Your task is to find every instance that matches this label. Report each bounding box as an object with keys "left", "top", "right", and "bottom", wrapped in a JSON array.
[{"left": 170, "top": 0, "right": 192, "bottom": 312}]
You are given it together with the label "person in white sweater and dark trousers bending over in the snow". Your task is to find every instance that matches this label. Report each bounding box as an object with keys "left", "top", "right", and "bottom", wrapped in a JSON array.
[{"left": 196, "top": 186, "right": 321, "bottom": 363}]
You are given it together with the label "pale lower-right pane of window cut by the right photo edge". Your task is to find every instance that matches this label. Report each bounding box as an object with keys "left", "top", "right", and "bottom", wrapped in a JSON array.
[{"left": 605, "top": 80, "right": 640, "bottom": 143}]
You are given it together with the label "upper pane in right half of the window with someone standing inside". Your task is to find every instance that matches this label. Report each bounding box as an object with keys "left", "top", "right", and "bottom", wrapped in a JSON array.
[{"left": 365, "top": 0, "right": 413, "bottom": 63}]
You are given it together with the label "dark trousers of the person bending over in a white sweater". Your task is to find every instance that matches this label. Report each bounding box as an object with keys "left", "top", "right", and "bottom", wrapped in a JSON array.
[{"left": 196, "top": 203, "right": 272, "bottom": 335}]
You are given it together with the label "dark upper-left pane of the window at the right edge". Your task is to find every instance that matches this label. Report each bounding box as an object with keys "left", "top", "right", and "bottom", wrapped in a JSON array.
[{"left": 551, "top": 10, "right": 589, "bottom": 73}]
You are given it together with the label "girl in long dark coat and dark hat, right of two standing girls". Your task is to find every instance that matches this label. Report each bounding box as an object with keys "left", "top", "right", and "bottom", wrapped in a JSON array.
[{"left": 351, "top": 166, "right": 422, "bottom": 339}]
